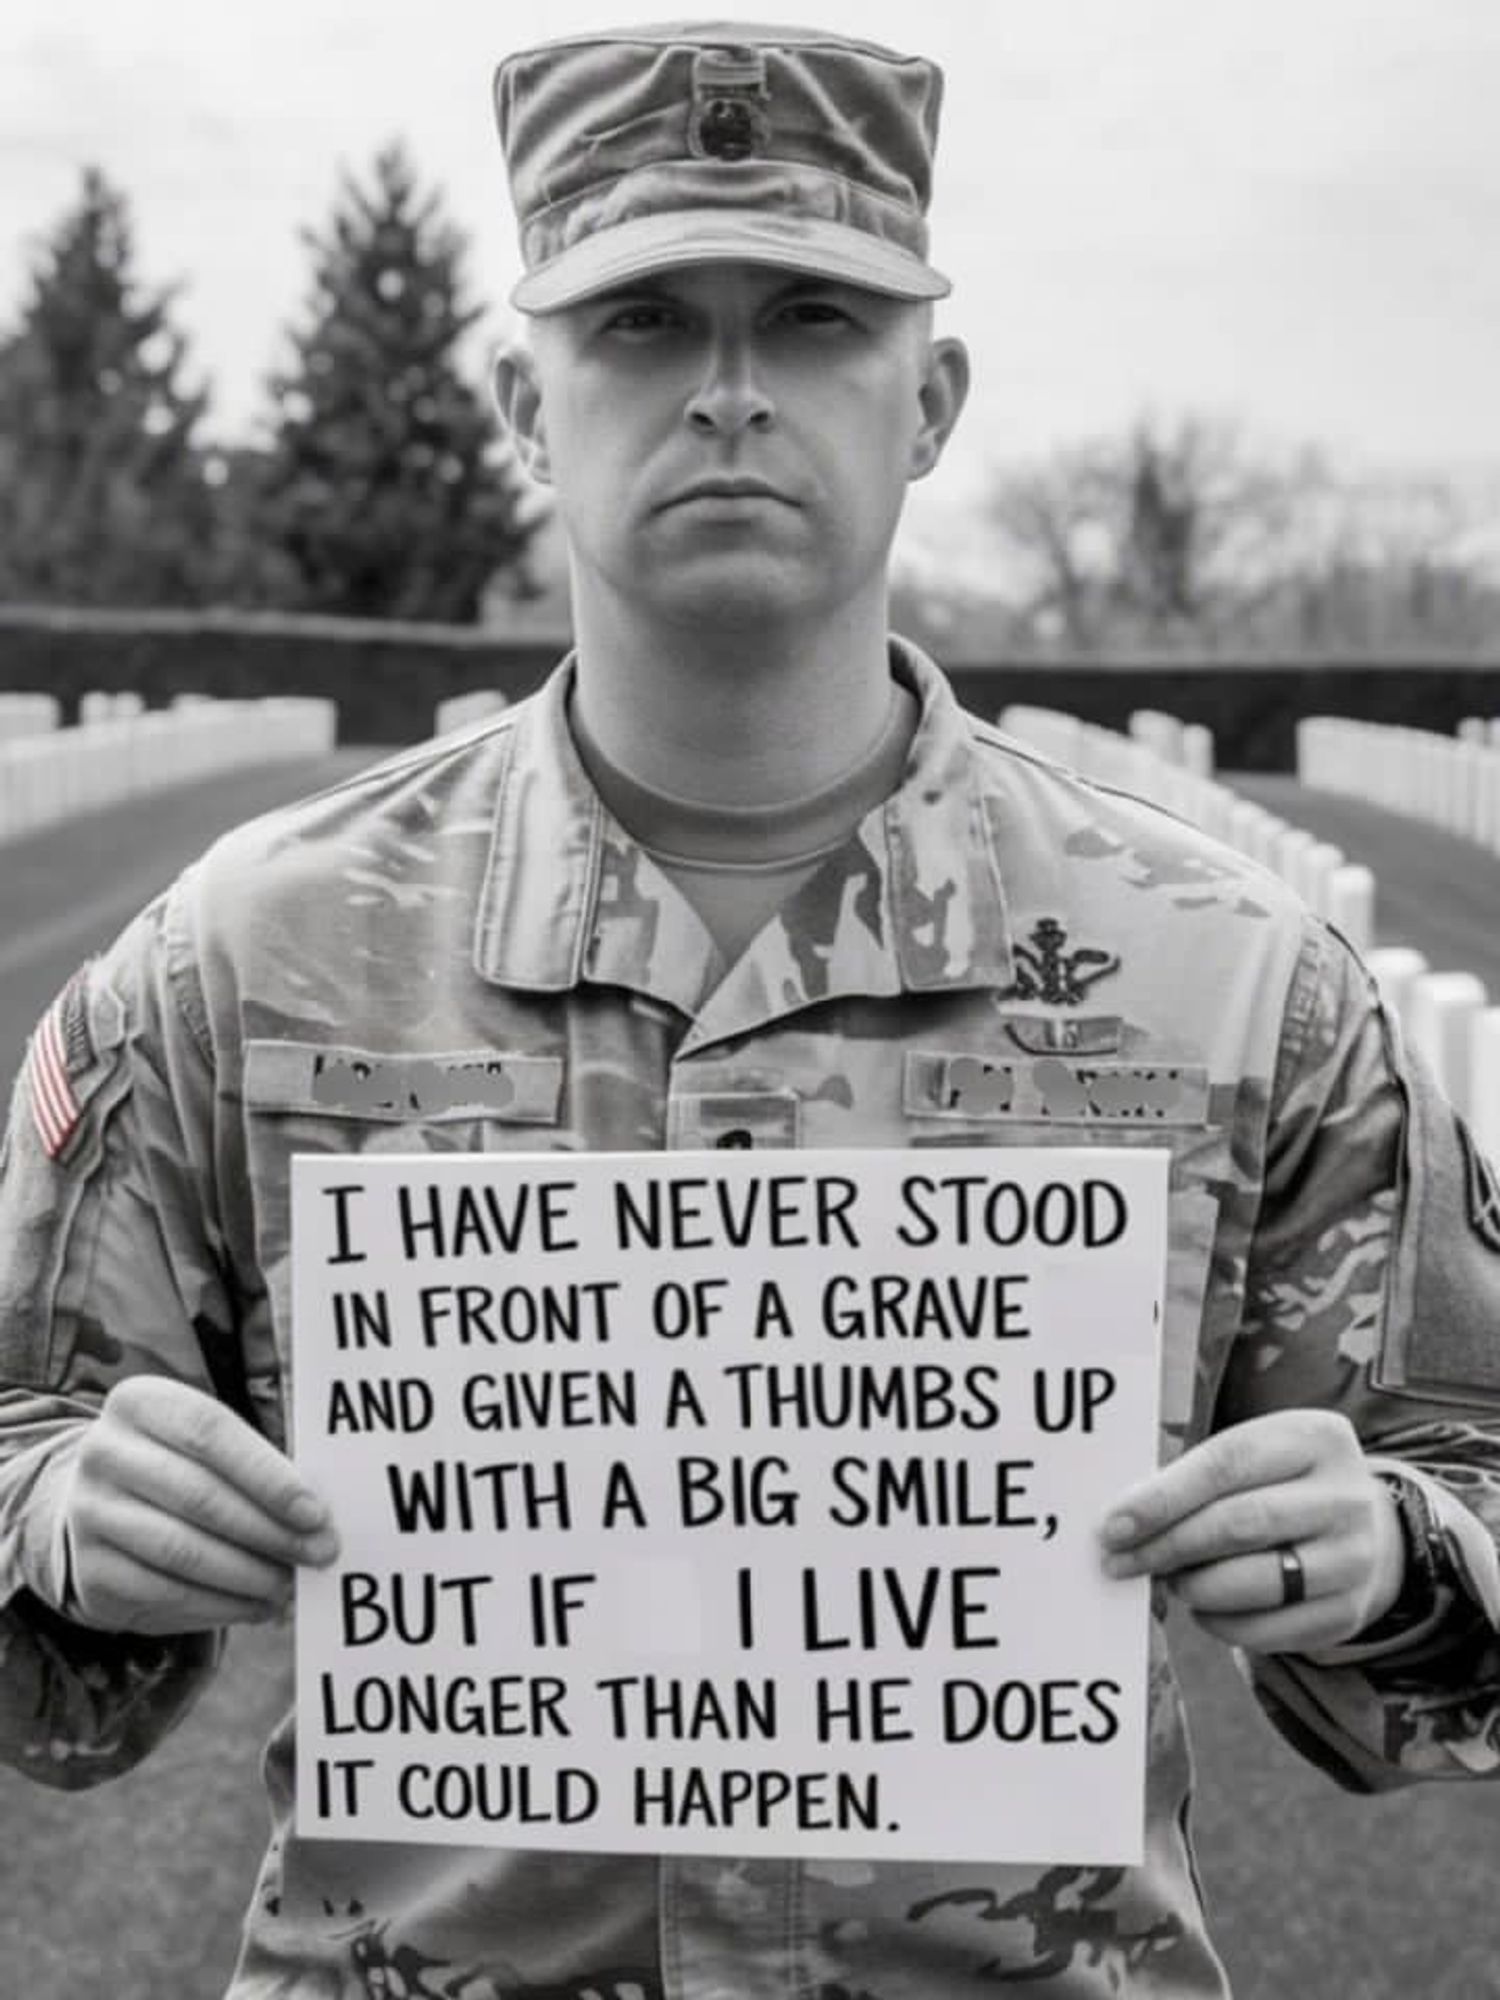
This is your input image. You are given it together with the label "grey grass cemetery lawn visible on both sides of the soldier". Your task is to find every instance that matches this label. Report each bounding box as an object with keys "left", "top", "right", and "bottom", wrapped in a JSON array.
[{"left": 0, "top": 750, "right": 1500, "bottom": 2000}]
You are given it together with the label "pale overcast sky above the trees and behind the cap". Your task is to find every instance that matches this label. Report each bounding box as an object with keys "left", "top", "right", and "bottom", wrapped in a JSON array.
[{"left": 0, "top": 0, "right": 1500, "bottom": 548}]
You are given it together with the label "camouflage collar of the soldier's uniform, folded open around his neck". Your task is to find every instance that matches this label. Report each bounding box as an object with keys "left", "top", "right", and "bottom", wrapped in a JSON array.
[{"left": 474, "top": 640, "right": 1012, "bottom": 1016}]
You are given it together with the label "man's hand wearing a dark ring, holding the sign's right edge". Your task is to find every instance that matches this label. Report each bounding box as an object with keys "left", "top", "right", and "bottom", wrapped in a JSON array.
[{"left": 1102, "top": 1410, "right": 1406, "bottom": 1652}]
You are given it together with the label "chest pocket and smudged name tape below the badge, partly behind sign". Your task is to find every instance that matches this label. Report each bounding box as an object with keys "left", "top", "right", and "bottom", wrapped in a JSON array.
[{"left": 902, "top": 1050, "right": 1234, "bottom": 1462}]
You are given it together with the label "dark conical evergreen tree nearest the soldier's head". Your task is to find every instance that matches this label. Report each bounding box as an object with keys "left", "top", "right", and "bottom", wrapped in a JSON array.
[{"left": 262, "top": 146, "right": 530, "bottom": 622}]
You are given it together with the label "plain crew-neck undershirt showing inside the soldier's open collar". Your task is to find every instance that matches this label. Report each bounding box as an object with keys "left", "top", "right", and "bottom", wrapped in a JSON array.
[{"left": 570, "top": 680, "right": 918, "bottom": 964}]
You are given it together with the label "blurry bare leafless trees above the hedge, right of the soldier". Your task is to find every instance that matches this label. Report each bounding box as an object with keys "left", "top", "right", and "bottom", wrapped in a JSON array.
[{"left": 990, "top": 416, "right": 1500, "bottom": 652}]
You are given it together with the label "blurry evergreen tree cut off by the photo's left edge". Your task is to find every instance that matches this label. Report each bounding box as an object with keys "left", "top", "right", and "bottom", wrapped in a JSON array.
[{"left": 0, "top": 168, "right": 216, "bottom": 604}]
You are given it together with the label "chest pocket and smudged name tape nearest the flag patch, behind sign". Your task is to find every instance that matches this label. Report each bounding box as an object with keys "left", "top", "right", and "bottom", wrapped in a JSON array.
[{"left": 244, "top": 1040, "right": 564, "bottom": 1366}]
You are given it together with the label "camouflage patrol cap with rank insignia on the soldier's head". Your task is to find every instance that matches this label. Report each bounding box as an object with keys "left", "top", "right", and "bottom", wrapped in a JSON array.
[{"left": 494, "top": 22, "right": 950, "bottom": 312}]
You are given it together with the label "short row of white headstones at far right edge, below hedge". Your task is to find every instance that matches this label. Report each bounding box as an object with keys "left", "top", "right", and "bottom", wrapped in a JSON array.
[{"left": 1296, "top": 716, "right": 1500, "bottom": 854}]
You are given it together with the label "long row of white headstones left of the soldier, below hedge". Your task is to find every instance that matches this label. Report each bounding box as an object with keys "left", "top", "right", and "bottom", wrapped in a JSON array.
[{"left": 0, "top": 694, "right": 338, "bottom": 842}]
